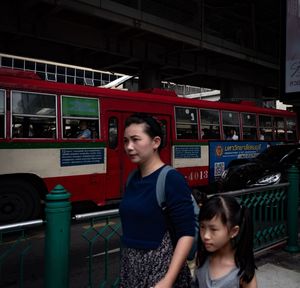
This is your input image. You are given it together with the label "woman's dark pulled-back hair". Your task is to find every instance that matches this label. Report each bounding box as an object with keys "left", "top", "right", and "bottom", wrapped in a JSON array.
[{"left": 125, "top": 113, "right": 163, "bottom": 150}]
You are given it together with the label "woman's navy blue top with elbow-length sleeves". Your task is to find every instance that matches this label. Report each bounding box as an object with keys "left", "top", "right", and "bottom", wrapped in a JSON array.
[{"left": 119, "top": 167, "right": 195, "bottom": 249}]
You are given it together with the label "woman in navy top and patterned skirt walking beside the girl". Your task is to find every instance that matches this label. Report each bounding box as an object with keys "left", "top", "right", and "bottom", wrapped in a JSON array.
[{"left": 120, "top": 113, "right": 195, "bottom": 288}]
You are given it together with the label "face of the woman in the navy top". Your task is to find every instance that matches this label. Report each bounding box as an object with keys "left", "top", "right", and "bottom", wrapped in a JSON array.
[{"left": 124, "top": 123, "right": 160, "bottom": 164}]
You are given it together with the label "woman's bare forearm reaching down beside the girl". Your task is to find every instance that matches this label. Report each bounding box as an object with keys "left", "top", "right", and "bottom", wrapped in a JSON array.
[{"left": 154, "top": 236, "right": 194, "bottom": 288}]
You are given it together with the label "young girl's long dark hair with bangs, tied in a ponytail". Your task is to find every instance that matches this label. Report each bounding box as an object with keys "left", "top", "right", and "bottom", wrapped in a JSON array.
[{"left": 196, "top": 196, "right": 256, "bottom": 283}]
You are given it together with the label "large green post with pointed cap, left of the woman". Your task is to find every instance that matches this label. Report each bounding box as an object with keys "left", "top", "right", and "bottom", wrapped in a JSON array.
[{"left": 44, "top": 185, "right": 71, "bottom": 288}]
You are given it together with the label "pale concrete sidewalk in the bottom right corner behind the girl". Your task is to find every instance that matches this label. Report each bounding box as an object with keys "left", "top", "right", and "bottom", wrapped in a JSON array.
[{"left": 255, "top": 246, "right": 300, "bottom": 288}]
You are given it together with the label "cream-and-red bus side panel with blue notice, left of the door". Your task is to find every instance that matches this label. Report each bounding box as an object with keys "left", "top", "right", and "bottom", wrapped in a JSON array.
[{"left": 0, "top": 142, "right": 109, "bottom": 205}]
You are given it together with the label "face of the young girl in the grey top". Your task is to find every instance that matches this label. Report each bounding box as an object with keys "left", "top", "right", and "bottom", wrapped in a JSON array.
[{"left": 200, "top": 216, "right": 238, "bottom": 252}]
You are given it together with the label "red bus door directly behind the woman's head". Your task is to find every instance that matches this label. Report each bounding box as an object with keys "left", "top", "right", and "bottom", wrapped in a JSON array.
[{"left": 106, "top": 111, "right": 171, "bottom": 199}]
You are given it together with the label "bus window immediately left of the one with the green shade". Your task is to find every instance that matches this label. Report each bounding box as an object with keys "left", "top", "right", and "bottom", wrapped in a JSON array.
[{"left": 12, "top": 91, "right": 56, "bottom": 138}]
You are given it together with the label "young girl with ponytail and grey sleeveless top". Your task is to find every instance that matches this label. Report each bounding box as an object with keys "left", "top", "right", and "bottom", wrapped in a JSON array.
[{"left": 192, "top": 196, "right": 257, "bottom": 288}]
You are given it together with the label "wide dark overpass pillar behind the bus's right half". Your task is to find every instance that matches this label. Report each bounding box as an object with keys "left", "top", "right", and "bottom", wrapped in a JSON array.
[{"left": 221, "top": 79, "right": 263, "bottom": 106}]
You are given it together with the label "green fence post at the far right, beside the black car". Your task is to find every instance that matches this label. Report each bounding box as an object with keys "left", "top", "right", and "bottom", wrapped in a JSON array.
[{"left": 284, "top": 166, "right": 300, "bottom": 252}]
